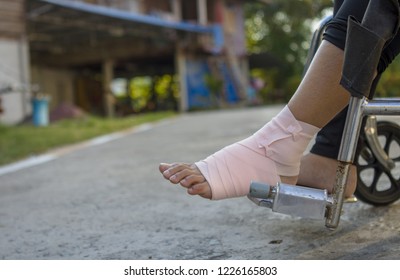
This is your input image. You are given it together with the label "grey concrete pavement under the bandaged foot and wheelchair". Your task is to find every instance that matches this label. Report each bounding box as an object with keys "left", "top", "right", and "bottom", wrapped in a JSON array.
[{"left": 0, "top": 106, "right": 400, "bottom": 260}]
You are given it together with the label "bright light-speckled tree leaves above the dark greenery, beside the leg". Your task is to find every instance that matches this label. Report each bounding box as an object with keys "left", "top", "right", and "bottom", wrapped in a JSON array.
[{"left": 245, "top": 0, "right": 332, "bottom": 70}]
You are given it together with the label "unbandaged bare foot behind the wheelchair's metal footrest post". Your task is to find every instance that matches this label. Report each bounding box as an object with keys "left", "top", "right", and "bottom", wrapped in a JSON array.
[{"left": 297, "top": 153, "right": 357, "bottom": 197}]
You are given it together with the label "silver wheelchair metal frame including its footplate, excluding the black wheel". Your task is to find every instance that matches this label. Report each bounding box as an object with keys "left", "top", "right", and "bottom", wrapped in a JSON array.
[{"left": 248, "top": 16, "right": 400, "bottom": 230}]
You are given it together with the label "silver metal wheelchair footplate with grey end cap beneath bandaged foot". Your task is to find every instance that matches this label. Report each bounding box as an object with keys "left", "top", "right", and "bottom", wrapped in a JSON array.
[{"left": 248, "top": 182, "right": 333, "bottom": 220}]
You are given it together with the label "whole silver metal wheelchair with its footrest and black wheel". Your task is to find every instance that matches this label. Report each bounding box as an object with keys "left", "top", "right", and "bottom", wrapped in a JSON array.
[{"left": 248, "top": 16, "right": 400, "bottom": 230}]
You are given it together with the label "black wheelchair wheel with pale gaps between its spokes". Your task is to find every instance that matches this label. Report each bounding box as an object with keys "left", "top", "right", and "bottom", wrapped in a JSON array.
[{"left": 354, "top": 121, "right": 400, "bottom": 206}]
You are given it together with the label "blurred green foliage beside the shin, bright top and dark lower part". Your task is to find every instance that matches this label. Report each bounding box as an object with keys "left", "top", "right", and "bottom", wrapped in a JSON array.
[{"left": 245, "top": 0, "right": 332, "bottom": 102}]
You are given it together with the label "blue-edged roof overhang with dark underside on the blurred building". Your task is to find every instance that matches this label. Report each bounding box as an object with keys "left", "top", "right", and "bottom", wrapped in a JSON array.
[{"left": 27, "top": 0, "right": 220, "bottom": 66}]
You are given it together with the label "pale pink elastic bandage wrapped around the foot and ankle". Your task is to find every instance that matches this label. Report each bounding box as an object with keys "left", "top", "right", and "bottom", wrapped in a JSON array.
[{"left": 195, "top": 106, "right": 319, "bottom": 200}]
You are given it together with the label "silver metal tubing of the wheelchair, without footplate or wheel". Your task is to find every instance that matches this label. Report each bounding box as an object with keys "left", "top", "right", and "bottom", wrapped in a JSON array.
[{"left": 305, "top": 16, "right": 400, "bottom": 229}]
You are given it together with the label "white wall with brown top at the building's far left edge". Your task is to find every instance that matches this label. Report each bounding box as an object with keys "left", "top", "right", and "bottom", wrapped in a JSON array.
[{"left": 0, "top": 0, "right": 31, "bottom": 123}]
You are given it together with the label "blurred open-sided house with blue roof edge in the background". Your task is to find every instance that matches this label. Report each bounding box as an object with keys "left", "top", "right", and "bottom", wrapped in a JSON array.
[{"left": 0, "top": 0, "right": 248, "bottom": 123}]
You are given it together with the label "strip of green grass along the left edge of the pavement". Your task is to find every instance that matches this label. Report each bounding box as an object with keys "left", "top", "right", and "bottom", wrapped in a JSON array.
[{"left": 0, "top": 112, "right": 175, "bottom": 165}]
